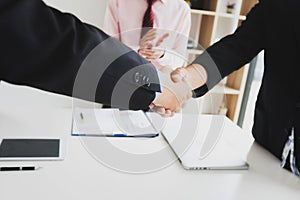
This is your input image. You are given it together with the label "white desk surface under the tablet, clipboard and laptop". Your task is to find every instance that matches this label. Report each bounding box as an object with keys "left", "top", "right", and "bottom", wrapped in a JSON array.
[{"left": 0, "top": 84, "right": 300, "bottom": 200}]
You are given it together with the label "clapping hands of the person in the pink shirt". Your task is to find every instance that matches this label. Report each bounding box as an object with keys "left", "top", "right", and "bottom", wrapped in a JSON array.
[{"left": 138, "top": 29, "right": 169, "bottom": 61}]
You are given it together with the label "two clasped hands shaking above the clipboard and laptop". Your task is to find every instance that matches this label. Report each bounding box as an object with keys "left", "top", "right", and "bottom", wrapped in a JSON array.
[{"left": 149, "top": 64, "right": 207, "bottom": 117}]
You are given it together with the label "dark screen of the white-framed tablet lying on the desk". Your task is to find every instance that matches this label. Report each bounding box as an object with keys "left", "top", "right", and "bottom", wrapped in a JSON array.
[{"left": 0, "top": 139, "right": 60, "bottom": 158}]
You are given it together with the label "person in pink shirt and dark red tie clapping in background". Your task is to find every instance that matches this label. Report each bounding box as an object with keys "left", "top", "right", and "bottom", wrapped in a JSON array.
[{"left": 104, "top": 0, "right": 191, "bottom": 69}]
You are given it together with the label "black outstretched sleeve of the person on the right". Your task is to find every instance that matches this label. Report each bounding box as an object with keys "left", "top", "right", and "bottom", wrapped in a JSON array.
[{"left": 193, "top": 0, "right": 268, "bottom": 97}]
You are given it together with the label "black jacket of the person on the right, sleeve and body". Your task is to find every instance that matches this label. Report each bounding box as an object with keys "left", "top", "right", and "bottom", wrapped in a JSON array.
[{"left": 194, "top": 0, "right": 300, "bottom": 159}]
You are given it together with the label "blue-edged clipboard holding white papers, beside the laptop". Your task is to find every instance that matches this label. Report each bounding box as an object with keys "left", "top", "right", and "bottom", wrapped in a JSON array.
[{"left": 72, "top": 108, "right": 158, "bottom": 137}]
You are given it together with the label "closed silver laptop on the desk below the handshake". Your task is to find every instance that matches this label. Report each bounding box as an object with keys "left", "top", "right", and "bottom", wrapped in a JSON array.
[{"left": 150, "top": 114, "right": 249, "bottom": 170}]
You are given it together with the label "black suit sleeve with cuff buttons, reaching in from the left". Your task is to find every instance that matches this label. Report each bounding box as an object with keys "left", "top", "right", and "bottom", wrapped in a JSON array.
[{"left": 0, "top": 0, "right": 160, "bottom": 109}]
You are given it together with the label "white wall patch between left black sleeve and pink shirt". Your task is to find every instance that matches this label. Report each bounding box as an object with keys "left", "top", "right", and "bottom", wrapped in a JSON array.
[{"left": 44, "top": 0, "right": 107, "bottom": 28}]
